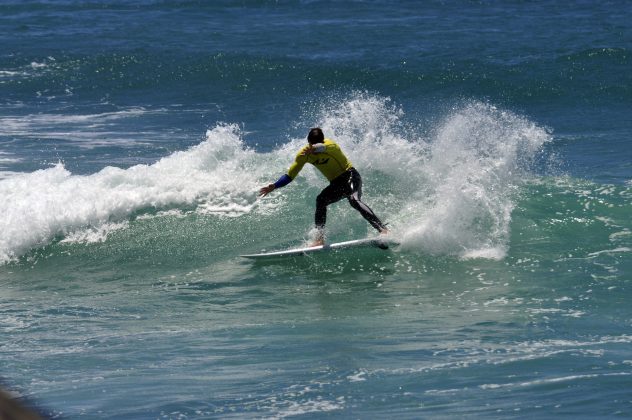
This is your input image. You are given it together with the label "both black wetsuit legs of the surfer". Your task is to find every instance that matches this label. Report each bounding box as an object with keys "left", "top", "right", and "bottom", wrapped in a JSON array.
[{"left": 314, "top": 168, "right": 386, "bottom": 232}]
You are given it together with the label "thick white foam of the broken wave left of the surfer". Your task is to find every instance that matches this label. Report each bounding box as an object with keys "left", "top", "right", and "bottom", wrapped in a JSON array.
[{"left": 0, "top": 125, "right": 266, "bottom": 263}]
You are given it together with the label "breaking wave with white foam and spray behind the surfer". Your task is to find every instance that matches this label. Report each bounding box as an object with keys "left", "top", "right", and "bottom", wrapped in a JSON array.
[{"left": 0, "top": 92, "right": 630, "bottom": 263}]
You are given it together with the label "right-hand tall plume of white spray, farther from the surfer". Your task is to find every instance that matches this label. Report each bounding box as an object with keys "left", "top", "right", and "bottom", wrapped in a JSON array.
[{"left": 403, "top": 102, "right": 551, "bottom": 259}]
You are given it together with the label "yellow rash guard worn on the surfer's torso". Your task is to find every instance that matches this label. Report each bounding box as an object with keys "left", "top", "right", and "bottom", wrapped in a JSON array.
[{"left": 287, "top": 139, "right": 353, "bottom": 181}]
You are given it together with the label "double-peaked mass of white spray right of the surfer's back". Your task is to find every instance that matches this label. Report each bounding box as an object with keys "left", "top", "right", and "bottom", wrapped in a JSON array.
[{"left": 308, "top": 94, "right": 551, "bottom": 259}]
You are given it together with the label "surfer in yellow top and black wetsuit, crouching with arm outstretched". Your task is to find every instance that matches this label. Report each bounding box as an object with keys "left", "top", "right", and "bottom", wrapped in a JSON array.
[{"left": 259, "top": 128, "right": 388, "bottom": 246}]
